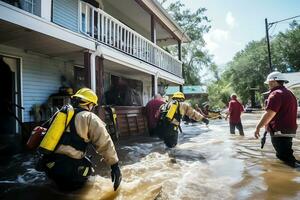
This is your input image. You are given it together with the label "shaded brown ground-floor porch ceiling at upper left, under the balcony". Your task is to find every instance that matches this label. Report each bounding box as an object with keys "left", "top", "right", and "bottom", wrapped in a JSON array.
[{"left": 0, "top": 20, "right": 84, "bottom": 59}]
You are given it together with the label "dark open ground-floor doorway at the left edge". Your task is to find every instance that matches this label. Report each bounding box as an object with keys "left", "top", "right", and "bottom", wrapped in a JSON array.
[{"left": 0, "top": 55, "right": 22, "bottom": 135}]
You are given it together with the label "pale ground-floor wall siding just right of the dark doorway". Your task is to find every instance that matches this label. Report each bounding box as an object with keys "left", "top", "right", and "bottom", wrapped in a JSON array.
[{"left": 0, "top": 45, "right": 69, "bottom": 122}]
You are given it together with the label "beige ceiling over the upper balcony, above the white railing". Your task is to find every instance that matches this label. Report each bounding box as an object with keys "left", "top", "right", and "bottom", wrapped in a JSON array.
[{"left": 104, "top": 0, "right": 177, "bottom": 46}]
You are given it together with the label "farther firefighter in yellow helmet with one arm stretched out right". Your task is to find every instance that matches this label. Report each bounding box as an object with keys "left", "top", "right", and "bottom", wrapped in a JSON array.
[{"left": 156, "top": 92, "right": 209, "bottom": 148}]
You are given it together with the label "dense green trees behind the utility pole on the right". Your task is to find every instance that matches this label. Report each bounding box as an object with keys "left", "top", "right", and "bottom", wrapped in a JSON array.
[{"left": 208, "top": 22, "right": 300, "bottom": 106}]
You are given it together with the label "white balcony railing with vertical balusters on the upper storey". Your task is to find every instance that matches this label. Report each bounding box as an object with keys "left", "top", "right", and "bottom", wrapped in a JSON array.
[{"left": 79, "top": 1, "right": 182, "bottom": 77}]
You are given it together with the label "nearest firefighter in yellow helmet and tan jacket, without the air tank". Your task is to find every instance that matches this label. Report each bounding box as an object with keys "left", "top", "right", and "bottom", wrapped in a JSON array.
[{"left": 38, "top": 88, "right": 122, "bottom": 190}]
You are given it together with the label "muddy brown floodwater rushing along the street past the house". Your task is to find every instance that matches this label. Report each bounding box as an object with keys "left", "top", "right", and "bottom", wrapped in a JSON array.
[{"left": 0, "top": 113, "right": 300, "bottom": 200}]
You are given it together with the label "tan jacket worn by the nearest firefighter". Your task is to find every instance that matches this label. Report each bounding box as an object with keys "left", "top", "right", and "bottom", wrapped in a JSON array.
[{"left": 55, "top": 111, "right": 119, "bottom": 165}]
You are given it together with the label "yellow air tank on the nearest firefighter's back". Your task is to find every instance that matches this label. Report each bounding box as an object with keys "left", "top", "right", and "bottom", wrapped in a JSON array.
[{"left": 39, "top": 105, "right": 74, "bottom": 153}]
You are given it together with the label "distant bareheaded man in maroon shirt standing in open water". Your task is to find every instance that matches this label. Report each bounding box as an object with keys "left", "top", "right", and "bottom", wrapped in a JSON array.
[{"left": 225, "top": 94, "right": 244, "bottom": 135}]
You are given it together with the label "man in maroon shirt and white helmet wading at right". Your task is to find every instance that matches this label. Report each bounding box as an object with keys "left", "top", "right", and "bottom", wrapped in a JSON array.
[{"left": 254, "top": 72, "right": 300, "bottom": 167}]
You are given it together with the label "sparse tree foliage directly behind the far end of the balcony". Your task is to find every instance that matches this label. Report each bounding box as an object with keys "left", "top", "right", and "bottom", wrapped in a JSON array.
[{"left": 160, "top": 0, "right": 210, "bottom": 85}]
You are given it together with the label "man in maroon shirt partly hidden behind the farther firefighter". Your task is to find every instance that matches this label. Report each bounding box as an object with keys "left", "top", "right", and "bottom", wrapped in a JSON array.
[{"left": 145, "top": 94, "right": 165, "bottom": 136}]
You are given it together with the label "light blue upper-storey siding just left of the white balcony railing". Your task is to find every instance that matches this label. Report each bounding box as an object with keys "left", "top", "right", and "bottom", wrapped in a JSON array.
[{"left": 52, "top": 0, "right": 78, "bottom": 32}]
